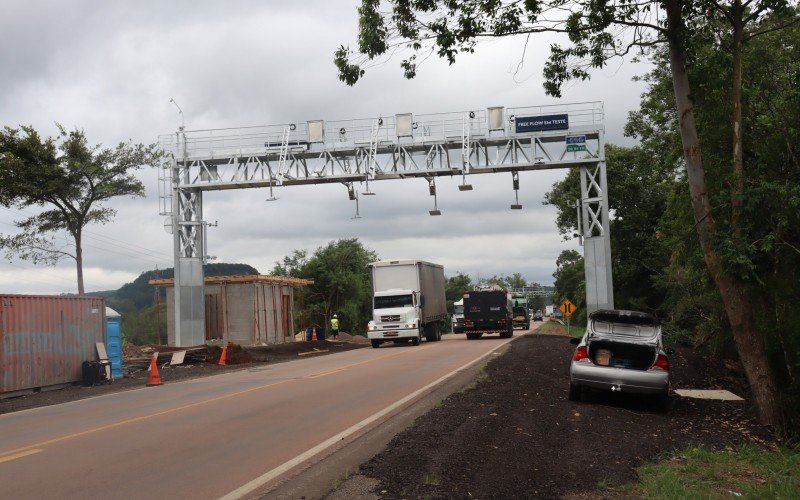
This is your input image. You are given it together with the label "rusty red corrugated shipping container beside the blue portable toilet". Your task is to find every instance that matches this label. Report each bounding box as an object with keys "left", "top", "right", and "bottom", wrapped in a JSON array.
[{"left": 0, "top": 295, "right": 105, "bottom": 394}]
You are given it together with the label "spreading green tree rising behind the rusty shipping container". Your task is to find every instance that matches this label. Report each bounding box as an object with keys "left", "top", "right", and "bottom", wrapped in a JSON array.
[{"left": 0, "top": 126, "right": 160, "bottom": 295}]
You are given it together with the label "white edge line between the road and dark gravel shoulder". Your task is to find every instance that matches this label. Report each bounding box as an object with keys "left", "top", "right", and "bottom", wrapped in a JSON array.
[{"left": 220, "top": 337, "right": 521, "bottom": 500}]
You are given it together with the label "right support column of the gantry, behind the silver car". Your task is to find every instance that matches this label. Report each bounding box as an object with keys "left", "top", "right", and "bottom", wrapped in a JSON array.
[{"left": 581, "top": 137, "right": 614, "bottom": 313}]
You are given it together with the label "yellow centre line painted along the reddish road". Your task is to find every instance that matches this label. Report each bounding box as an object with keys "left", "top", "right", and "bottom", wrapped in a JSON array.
[{"left": 0, "top": 347, "right": 434, "bottom": 462}]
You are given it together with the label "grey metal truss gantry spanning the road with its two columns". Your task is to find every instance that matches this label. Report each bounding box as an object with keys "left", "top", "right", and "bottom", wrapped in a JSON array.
[{"left": 159, "top": 102, "right": 613, "bottom": 345}]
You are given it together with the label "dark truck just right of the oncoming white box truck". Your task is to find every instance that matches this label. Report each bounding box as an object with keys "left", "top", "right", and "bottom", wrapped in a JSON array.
[{"left": 464, "top": 290, "right": 514, "bottom": 340}]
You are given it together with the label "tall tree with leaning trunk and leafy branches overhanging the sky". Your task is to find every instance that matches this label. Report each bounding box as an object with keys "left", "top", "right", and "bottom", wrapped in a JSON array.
[{"left": 334, "top": 0, "right": 797, "bottom": 424}]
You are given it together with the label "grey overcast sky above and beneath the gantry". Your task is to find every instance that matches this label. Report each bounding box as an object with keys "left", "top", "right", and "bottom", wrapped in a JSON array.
[{"left": 0, "top": 0, "right": 646, "bottom": 293}]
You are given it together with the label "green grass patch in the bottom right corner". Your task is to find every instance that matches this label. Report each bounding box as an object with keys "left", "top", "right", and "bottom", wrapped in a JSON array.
[{"left": 604, "top": 445, "right": 800, "bottom": 499}]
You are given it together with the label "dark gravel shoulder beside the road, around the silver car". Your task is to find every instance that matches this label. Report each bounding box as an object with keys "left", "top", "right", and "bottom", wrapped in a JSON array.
[{"left": 332, "top": 335, "right": 769, "bottom": 498}]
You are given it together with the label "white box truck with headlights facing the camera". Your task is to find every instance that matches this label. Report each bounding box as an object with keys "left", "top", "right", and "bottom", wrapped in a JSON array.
[{"left": 367, "top": 259, "right": 447, "bottom": 348}]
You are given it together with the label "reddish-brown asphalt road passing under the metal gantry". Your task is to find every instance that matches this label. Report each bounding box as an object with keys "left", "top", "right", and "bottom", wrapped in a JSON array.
[{"left": 0, "top": 331, "right": 522, "bottom": 499}]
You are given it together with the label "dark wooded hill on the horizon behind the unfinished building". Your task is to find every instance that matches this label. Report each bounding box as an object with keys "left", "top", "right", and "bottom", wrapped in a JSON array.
[{"left": 87, "top": 263, "right": 259, "bottom": 313}]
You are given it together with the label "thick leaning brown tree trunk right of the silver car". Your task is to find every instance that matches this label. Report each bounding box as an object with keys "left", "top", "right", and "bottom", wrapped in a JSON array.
[{"left": 665, "top": 0, "right": 781, "bottom": 426}]
